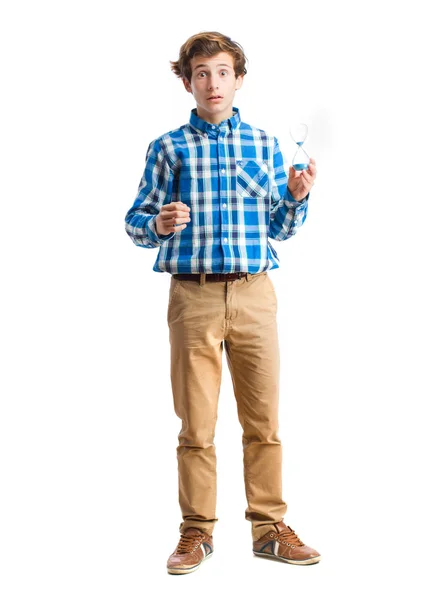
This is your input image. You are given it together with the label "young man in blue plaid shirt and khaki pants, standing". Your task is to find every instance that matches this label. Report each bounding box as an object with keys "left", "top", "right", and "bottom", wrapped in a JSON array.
[{"left": 126, "top": 32, "right": 320, "bottom": 574}]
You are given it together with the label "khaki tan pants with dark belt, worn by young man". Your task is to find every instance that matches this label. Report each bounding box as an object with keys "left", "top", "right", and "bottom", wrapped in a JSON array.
[{"left": 168, "top": 272, "right": 287, "bottom": 540}]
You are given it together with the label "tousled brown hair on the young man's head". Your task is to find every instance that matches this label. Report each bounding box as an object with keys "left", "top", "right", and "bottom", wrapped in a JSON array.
[{"left": 170, "top": 31, "right": 247, "bottom": 82}]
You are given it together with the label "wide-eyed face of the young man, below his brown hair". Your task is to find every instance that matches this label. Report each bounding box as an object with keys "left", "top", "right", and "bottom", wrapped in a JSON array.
[{"left": 183, "top": 52, "right": 243, "bottom": 123}]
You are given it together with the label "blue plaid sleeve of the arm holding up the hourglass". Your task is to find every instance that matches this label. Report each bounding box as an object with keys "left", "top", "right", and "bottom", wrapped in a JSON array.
[{"left": 268, "top": 138, "right": 310, "bottom": 241}]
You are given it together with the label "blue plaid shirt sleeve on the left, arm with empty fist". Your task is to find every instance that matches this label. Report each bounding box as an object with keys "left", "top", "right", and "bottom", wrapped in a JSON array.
[{"left": 125, "top": 140, "right": 175, "bottom": 248}]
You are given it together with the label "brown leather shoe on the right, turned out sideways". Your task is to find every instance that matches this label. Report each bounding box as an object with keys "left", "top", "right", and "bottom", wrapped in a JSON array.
[{"left": 253, "top": 521, "right": 320, "bottom": 565}]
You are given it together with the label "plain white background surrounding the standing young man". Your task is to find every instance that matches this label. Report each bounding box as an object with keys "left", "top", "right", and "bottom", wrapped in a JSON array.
[{"left": 0, "top": 0, "right": 435, "bottom": 600}]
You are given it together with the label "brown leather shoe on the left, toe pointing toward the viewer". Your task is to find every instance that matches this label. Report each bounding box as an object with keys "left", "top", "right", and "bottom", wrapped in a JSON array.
[{"left": 167, "top": 527, "right": 213, "bottom": 575}]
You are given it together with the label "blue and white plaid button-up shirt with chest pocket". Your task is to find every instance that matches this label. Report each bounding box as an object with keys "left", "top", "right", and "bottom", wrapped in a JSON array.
[{"left": 125, "top": 107, "right": 309, "bottom": 273}]
